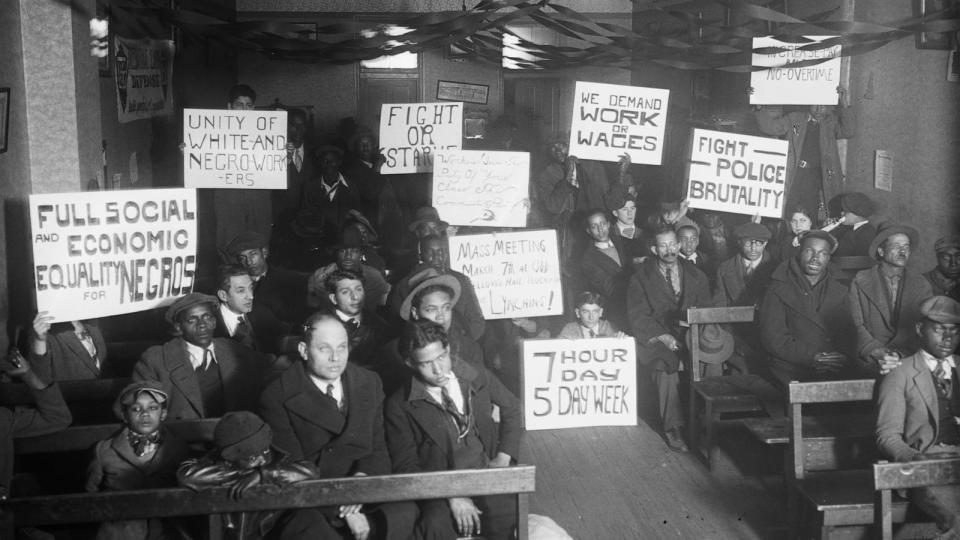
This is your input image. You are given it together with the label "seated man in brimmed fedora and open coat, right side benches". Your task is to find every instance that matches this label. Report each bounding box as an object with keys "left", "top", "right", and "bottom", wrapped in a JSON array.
[{"left": 847, "top": 224, "right": 933, "bottom": 375}]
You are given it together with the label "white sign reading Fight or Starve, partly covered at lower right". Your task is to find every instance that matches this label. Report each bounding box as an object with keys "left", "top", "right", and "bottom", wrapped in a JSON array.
[{"left": 380, "top": 102, "right": 463, "bottom": 174}]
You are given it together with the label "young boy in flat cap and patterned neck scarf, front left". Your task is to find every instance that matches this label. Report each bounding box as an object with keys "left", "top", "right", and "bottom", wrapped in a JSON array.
[{"left": 86, "top": 381, "right": 187, "bottom": 540}]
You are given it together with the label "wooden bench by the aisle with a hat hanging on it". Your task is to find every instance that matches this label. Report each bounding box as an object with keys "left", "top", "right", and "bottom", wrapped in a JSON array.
[{"left": 686, "top": 306, "right": 779, "bottom": 469}]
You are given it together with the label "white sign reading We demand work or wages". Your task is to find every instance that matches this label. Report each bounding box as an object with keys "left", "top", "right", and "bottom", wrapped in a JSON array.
[{"left": 570, "top": 81, "right": 670, "bottom": 165}]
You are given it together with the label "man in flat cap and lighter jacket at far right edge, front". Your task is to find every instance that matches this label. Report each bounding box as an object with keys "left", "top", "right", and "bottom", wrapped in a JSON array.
[{"left": 877, "top": 296, "right": 960, "bottom": 538}]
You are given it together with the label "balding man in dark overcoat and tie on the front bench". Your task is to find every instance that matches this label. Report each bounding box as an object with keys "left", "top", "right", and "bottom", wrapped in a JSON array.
[{"left": 260, "top": 312, "right": 416, "bottom": 540}]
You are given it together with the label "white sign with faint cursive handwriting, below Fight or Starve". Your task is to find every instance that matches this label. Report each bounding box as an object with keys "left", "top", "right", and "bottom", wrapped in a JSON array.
[{"left": 433, "top": 150, "right": 530, "bottom": 227}]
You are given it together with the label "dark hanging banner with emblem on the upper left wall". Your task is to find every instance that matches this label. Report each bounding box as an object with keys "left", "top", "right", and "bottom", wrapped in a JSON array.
[{"left": 114, "top": 36, "right": 173, "bottom": 123}]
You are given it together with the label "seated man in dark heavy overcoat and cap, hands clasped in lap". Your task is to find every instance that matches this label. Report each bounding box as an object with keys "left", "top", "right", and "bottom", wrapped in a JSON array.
[{"left": 758, "top": 231, "right": 858, "bottom": 387}]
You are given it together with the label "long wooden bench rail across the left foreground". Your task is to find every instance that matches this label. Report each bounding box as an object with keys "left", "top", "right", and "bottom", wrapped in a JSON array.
[{"left": 0, "top": 465, "right": 536, "bottom": 540}]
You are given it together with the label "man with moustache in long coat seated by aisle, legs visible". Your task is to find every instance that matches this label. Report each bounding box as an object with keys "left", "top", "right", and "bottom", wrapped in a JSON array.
[{"left": 627, "top": 227, "right": 713, "bottom": 452}]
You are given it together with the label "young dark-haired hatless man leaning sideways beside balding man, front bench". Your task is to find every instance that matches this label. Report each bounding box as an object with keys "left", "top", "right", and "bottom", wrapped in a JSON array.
[{"left": 384, "top": 321, "right": 523, "bottom": 540}]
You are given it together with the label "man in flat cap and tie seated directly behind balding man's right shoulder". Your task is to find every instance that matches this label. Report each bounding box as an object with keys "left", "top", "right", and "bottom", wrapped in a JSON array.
[{"left": 133, "top": 293, "right": 270, "bottom": 420}]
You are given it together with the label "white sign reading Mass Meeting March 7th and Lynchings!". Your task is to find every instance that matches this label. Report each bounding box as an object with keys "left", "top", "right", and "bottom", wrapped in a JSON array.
[{"left": 441, "top": 229, "right": 563, "bottom": 319}]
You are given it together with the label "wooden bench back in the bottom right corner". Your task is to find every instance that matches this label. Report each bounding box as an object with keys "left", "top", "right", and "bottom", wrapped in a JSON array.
[{"left": 873, "top": 457, "right": 960, "bottom": 540}]
